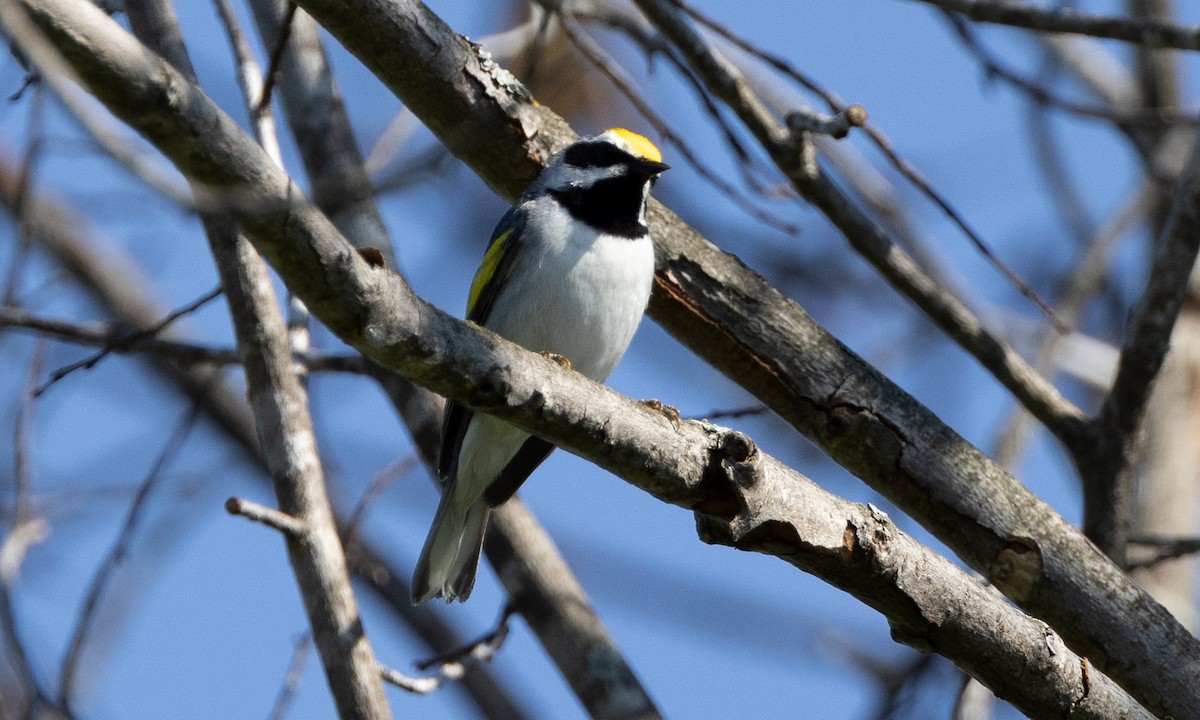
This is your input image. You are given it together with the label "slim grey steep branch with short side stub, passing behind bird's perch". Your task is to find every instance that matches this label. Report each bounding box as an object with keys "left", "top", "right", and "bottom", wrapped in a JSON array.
[{"left": 118, "top": 0, "right": 391, "bottom": 720}]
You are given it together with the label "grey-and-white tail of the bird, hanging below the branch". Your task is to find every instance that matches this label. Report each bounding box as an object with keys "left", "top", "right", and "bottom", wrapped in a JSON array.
[{"left": 413, "top": 491, "right": 491, "bottom": 605}]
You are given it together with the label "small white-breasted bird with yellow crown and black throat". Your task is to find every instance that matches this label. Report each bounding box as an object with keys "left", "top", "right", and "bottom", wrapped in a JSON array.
[{"left": 412, "top": 127, "right": 668, "bottom": 604}]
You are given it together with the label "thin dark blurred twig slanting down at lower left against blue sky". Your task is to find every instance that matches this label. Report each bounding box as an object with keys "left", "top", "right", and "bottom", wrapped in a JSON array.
[{"left": 58, "top": 403, "right": 200, "bottom": 709}]
